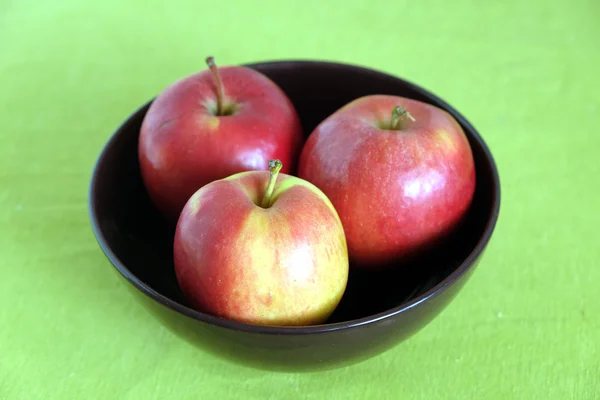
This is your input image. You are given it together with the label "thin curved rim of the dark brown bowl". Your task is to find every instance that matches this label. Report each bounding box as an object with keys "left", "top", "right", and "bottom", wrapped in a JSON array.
[{"left": 88, "top": 59, "right": 501, "bottom": 335}]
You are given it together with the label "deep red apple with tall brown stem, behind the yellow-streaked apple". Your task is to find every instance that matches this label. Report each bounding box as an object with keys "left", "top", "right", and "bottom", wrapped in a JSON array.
[{"left": 138, "top": 57, "right": 303, "bottom": 221}]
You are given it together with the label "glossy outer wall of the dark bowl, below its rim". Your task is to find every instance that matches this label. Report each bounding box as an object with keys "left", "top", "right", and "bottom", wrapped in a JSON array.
[{"left": 128, "top": 260, "right": 473, "bottom": 372}]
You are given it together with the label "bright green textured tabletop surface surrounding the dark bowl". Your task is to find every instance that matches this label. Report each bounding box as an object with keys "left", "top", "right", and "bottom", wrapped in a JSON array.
[{"left": 0, "top": 0, "right": 600, "bottom": 400}]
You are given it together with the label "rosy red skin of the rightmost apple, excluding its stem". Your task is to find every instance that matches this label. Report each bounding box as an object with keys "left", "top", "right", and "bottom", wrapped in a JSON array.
[{"left": 298, "top": 95, "right": 476, "bottom": 269}]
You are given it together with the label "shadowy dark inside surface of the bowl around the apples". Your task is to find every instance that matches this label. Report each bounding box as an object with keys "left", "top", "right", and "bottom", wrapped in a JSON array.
[{"left": 90, "top": 61, "right": 498, "bottom": 323}]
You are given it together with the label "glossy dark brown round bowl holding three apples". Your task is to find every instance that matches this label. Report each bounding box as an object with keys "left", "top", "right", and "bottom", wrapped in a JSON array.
[{"left": 89, "top": 61, "right": 500, "bottom": 370}]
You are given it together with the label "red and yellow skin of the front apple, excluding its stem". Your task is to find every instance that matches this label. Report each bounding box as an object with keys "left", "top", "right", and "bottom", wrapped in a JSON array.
[{"left": 174, "top": 171, "right": 349, "bottom": 326}]
